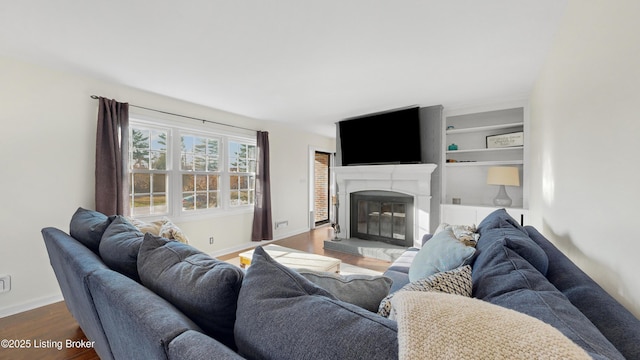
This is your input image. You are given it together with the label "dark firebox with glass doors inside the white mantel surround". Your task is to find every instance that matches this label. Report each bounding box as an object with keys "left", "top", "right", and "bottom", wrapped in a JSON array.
[{"left": 350, "top": 191, "right": 414, "bottom": 247}]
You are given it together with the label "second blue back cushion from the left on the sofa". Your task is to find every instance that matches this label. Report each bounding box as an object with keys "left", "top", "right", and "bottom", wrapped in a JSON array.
[{"left": 99, "top": 215, "right": 144, "bottom": 282}]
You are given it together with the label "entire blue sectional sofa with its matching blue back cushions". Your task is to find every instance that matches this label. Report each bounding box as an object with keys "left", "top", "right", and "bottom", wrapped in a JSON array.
[{"left": 42, "top": 209, "right": 640, "bottom": 360}]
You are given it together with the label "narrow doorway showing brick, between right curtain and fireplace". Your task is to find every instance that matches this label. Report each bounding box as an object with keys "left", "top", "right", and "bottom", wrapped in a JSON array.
[{"left": 313, "top": 151, "right": 331, "bottom": 227}]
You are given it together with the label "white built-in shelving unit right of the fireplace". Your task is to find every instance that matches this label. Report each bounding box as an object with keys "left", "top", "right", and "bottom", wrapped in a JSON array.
[{"left": 441, "top": 101, "right": 529, "bottom": 224}]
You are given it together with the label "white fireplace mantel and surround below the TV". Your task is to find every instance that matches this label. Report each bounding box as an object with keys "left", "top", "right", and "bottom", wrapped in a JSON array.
[{"left": 333, "top": 164, "right": 437, "bottom": 247}]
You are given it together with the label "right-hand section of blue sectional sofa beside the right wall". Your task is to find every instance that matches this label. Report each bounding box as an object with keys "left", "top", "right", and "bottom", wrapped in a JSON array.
[{"left": 385, "top": 209, "right": 640, "bottom": 359}]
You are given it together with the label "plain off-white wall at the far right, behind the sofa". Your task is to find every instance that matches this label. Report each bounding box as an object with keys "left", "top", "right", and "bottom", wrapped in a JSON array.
[{"left": 531, "top": 0, "right": 640, "bottom": 317}]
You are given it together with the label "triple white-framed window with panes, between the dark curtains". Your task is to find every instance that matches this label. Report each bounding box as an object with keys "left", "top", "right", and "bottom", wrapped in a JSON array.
[{"left": 129, "top": 119, "right": 256, "bottom": 217}]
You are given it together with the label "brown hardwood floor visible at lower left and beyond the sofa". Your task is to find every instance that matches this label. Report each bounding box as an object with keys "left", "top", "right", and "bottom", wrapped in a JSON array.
[{"left": 0, "top": 226, "right": 390, "bottom": 360}]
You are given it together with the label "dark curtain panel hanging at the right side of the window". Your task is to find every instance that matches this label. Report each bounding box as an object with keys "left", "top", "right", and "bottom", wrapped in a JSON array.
[{"left": 251, "top": 131, "right": 273, "bottom": 241}]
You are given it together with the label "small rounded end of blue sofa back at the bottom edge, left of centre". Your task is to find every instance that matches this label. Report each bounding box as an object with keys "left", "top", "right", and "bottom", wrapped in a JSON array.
[{"left": 168, "top": 330, "right": 244, "bottom": 360}]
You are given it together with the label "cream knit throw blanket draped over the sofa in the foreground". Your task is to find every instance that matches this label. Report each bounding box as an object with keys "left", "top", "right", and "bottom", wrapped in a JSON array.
[{"left": 391, "top": 291, "right": 591, "bottom": 360}]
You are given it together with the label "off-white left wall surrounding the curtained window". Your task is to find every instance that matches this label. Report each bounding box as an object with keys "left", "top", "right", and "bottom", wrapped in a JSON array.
[{"left": 0, "top": 57, "right": 334, "bottom": 317}]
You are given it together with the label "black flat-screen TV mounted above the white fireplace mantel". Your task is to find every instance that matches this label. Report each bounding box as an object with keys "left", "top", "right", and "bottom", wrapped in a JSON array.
[{"left": 338, "top": 107, "right": 422, "bottom": 166}]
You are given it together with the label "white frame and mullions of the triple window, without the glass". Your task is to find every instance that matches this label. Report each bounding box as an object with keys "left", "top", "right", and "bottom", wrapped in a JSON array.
[{"left": 126, "top": 114, "right": 257, "bottom": 221}]
